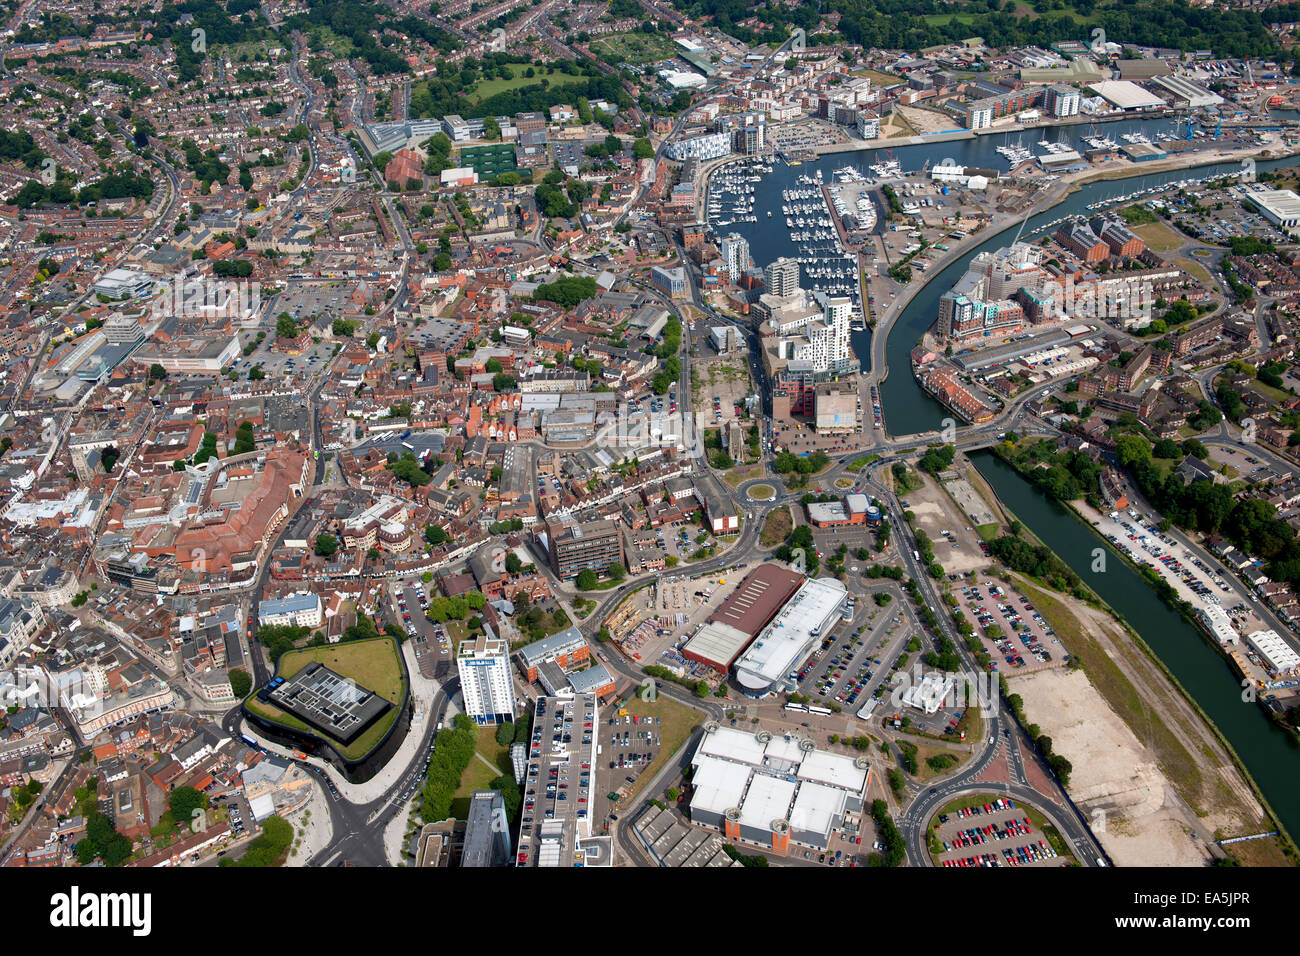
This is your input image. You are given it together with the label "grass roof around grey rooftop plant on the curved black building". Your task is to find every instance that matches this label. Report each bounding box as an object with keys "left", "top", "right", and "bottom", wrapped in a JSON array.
[{"left": 247, "top": 637, "right": 406, "bottom": 760}]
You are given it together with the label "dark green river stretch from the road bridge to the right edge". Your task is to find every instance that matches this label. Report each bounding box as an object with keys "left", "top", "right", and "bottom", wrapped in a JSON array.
[{"left": 971, "top": 451, "right": 1300, "bottom": 836}]
